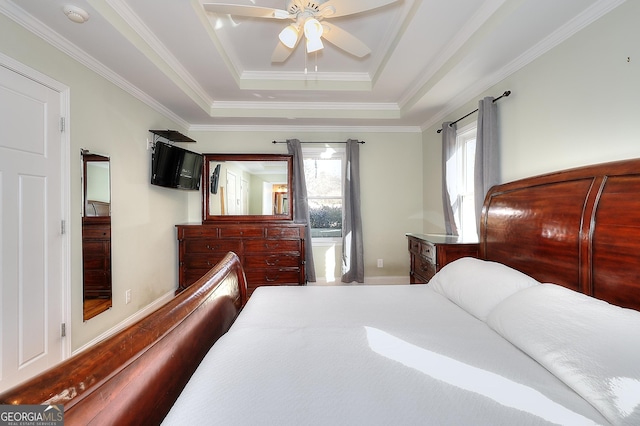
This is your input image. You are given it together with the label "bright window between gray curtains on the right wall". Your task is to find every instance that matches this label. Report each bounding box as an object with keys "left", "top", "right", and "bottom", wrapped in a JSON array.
[{"left": 452, "top": 123, "right": 478, "bottom": 239}]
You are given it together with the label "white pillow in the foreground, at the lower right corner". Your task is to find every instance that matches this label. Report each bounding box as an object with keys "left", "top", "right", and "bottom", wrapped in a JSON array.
[{"left": 487, "top": 284, "right": 640, "bottom": 425}]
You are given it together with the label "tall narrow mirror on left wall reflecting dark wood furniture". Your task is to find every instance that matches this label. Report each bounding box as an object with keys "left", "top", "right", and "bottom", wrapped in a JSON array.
[{"left": 81, "top": 150, "right": 112, "bottom": 321}]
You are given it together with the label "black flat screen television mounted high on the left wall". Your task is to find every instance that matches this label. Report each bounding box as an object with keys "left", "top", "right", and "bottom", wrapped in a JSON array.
[{"left": 151, "top": 142, "right": 203, "bottom": 190}]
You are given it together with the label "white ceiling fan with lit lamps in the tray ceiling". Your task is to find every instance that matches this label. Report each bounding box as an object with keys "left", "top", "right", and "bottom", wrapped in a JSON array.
[{"left": 202, "top": 0, "right": 399, "bottom": 62}]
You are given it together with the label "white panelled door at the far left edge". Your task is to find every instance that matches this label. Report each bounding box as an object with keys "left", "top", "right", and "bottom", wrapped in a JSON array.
[{"left": 0, "top": 65, "right": 66, "bottom": 390}]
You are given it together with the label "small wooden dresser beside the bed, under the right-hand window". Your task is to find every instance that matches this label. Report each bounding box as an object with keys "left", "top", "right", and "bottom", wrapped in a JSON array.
[{"left": 407, "top": 234, "right": 479, "bottom": 284}]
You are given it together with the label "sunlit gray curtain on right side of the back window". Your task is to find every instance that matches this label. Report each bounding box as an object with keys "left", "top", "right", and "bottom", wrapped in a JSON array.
[{"left": 342, "top": 139, "right": 364, "bottom": 283}]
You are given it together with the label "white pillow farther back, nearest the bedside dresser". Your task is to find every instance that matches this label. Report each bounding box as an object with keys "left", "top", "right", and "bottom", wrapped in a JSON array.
[{"left": 429, "top": 257, "right": 540, "bottom": 321}]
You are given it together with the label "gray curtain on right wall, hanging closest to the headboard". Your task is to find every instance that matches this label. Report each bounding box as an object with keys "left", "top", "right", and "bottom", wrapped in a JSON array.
[{"left": 473, "top": 96, "right": 500, "bottom": 236}]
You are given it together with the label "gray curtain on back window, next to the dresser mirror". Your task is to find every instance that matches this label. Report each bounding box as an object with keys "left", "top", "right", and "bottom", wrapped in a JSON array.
[{"left": 287, "top": 139, "right": 316, "bottom": 283}]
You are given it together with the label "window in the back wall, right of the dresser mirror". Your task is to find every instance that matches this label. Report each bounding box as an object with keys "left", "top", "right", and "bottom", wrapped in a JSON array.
[{"left": 302, "top": 147, "right": 345, "bottom": 242}]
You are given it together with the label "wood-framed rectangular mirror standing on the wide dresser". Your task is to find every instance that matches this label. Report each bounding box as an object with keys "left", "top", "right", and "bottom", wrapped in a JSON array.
[{"left": 202, "top": 154, "right": 293, "bottom": 222}]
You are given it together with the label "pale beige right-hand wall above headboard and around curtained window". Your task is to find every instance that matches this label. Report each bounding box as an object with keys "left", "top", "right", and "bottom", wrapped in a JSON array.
[{"left": 423, "top": 1, "right": 640, "bottom": 232}]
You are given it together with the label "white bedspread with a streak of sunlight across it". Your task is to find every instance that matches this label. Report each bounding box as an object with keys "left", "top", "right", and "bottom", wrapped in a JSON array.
[{"left": 164, "top": 285, "right": 607, "bottom": 425}]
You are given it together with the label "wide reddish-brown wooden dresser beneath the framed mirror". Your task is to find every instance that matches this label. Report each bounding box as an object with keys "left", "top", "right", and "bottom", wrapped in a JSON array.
[{"left": 176, "top": 221, "right": 306, "bottom": 295}]
